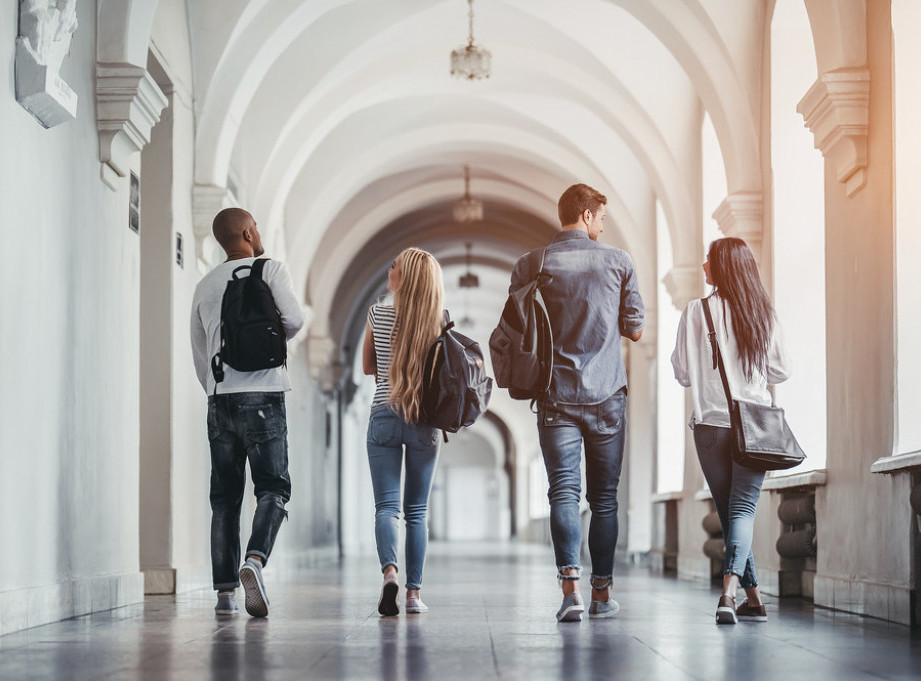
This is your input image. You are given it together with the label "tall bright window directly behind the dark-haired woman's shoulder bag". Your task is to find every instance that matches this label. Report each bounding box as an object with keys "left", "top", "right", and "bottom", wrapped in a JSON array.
[{"left": 771, "top": 0, "right": 826, "bottom": 472}]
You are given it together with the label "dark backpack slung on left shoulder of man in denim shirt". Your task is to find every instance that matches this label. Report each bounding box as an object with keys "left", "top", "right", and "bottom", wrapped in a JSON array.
[{"left": 489, "top": 249, "right": 553, "bottom": 400}]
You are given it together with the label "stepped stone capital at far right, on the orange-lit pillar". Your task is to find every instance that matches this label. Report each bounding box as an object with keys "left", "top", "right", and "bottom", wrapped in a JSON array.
[{"left": 796, "top": 68, "right": 870, "bottom": 196}]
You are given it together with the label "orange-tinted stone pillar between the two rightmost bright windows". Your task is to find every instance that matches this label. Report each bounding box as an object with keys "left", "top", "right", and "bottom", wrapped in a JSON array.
[{"left": 802, "top": 2, "right": 913, "bottom": 624}]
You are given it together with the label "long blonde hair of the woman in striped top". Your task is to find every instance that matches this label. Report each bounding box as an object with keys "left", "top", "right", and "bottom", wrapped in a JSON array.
[{"left": 389, "top": 248, "right": 444, "bottom": 423}]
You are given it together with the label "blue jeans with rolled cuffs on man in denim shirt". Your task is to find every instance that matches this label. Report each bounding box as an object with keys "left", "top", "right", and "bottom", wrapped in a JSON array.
[{"left": 537, "top": 389, "right": 627, "bottom": 580}]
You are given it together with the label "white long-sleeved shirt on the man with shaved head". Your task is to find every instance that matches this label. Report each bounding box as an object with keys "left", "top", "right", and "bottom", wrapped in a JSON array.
[{"left": 191, "top": 258, "right": 304, "bottom": 395}]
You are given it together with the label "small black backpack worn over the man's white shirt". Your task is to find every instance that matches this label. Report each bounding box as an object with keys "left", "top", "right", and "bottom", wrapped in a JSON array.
[{"left": 211, "top": 258, "right": 288, "bottom": 390}]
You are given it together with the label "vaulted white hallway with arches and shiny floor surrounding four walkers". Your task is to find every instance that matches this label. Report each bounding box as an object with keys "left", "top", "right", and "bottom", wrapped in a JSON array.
[{"left": 0, "top": 0, "right": 921, "bottom": 668}]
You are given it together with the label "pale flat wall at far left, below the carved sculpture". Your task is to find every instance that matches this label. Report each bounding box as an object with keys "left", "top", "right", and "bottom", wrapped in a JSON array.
[{"left": 0, "top": 2, "right": 142, "bottom": 633}]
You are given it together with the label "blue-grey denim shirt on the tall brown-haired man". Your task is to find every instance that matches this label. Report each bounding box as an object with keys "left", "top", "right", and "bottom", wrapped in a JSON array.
[{"left": 509, "top": 229, "right": 645, "bottom": 404}]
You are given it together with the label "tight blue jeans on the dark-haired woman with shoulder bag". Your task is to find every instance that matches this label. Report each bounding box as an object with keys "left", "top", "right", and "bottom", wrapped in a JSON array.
[{"left": 694, "top": 424, "right": 764, "bottom": 589}]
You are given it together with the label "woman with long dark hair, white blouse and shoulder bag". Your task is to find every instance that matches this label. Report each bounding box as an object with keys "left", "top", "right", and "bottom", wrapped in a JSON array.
[{"left": 672, "top": 238, "right": 790, "bottom": 624}]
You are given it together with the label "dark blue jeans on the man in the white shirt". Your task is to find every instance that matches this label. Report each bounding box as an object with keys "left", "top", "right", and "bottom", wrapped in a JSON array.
[{"left": 208, "top": 392, "right": 291, "bottom": 590}]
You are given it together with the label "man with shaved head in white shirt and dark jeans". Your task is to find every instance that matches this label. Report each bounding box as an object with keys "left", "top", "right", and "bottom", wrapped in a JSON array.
[{"left": 191, "top": 208, "right": 304, "bottom": 617}]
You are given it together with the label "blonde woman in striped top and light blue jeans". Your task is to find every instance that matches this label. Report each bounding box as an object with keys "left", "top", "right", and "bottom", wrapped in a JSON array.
[{"left": 362, "top": 248, "right": 444, "bottom": 616}]
